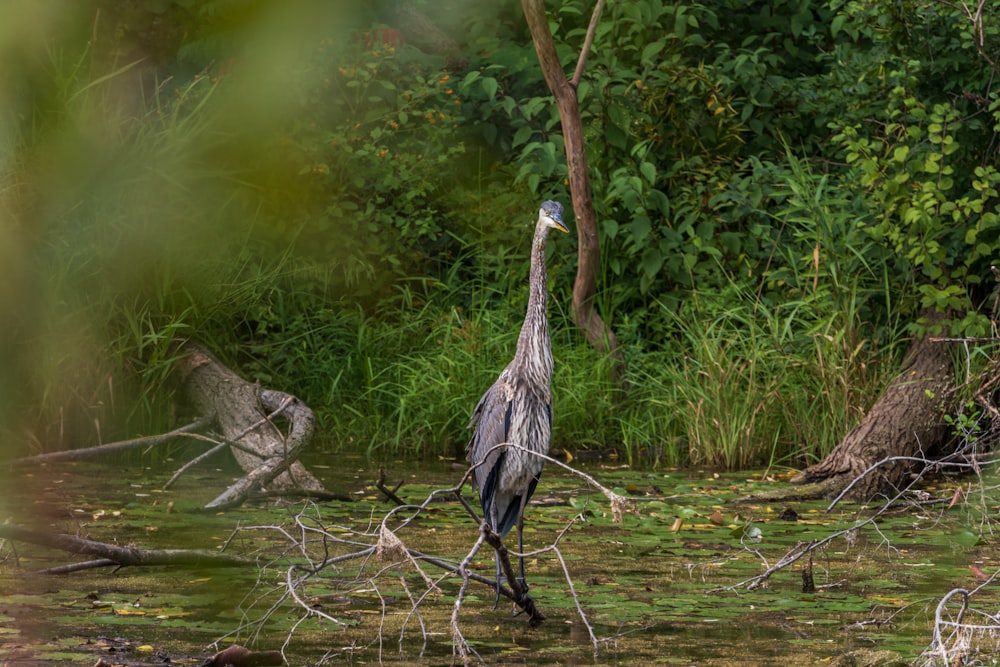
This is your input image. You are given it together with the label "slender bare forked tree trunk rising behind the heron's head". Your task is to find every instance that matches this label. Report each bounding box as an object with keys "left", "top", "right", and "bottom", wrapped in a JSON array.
[{"left": 521, "top": 0, "right": 628, "bottom": 392}]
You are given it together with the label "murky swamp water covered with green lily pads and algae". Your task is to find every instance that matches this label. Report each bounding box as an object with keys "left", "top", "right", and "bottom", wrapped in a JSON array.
[{"left": 0, "top": 455, "right": 1000, "bottom": 667}]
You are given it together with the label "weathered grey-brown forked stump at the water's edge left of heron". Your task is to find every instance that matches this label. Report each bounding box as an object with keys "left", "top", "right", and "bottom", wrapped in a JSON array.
[{"left": 178, "top": 343, "right": 325, "bottom": 507}]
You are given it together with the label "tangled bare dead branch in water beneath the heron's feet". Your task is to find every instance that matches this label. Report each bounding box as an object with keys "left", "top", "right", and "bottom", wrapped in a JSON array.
[{"left": 220, "top": 456, "right": 628, "bottom": 664}]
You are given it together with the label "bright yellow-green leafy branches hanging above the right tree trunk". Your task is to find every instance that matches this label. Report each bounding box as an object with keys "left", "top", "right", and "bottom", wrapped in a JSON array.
[{"left": 831, "top": 3, "right": 1000, "bottom": 336}]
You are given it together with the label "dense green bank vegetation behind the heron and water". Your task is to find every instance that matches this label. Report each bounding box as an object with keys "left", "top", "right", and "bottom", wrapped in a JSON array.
[{"left": 0, "top": 0, "right": 1000, "bottom": 468}]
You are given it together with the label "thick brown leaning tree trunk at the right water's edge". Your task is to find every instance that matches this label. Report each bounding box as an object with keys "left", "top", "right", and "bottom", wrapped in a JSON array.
[{"left": 791, "top": 312, "right": 955, "bottom": 500}]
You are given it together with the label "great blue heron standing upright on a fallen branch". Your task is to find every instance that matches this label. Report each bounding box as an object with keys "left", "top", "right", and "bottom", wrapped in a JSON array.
[{"left": 468, "top": 200, "right": 568, "bottom": 602}]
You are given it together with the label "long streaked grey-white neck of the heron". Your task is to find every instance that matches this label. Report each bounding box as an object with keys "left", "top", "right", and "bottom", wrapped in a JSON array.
[{"left": 515, "top": 224, "right": 552, "bottom": 387}]
